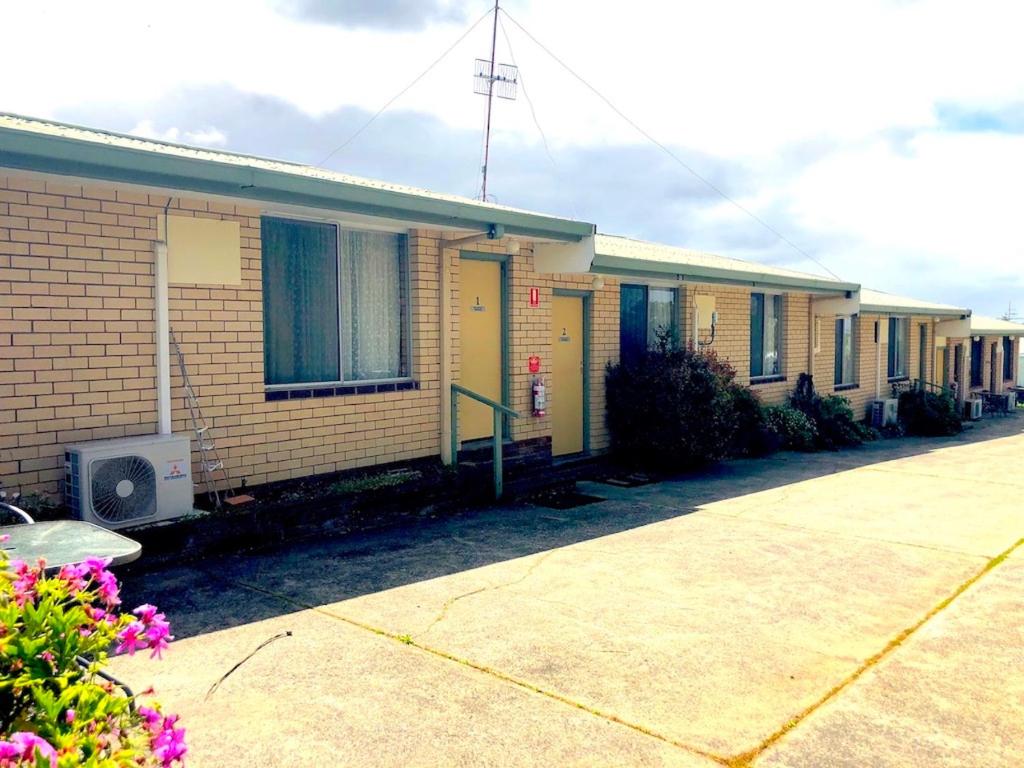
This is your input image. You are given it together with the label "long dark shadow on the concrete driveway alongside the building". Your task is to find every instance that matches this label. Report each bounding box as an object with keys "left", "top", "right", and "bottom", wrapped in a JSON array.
[{"left": 117, "top": 417, "right": 1024, "bottom": 639}]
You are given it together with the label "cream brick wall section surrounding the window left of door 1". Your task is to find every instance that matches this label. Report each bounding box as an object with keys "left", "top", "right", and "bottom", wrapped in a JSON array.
[{"left": 0, "top": 176, "right": 440, "bottom": 493}]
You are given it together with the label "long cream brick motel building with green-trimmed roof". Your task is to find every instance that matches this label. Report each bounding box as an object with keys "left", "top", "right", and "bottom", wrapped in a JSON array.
[{"left": 0, "top": 116, "right": 1007, "bottom": 505}]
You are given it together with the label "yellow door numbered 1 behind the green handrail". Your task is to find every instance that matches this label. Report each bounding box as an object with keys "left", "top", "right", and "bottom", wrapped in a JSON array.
[{"left": 459, "top": 259, "right": 502, "bottom": 440}]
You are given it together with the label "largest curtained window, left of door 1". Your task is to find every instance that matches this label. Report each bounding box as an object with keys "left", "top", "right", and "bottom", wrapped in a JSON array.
[{"left": 260, "top": 217, "right": 410, "bottom": 386}]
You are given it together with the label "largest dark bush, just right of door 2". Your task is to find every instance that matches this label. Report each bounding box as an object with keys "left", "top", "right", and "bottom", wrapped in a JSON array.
[{"left": 605, "top": 339, "right": 749, "bottom": 472}]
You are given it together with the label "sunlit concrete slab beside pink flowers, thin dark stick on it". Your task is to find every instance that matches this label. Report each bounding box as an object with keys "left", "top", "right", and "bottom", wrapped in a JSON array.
[{"left": 105, "top": 611, "right": 715, "bottom": 768}]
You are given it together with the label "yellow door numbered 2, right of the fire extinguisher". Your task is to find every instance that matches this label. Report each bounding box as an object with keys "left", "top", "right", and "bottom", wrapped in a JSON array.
[{"left": 550, "top": 296, "right": 585, "bottom": 456}]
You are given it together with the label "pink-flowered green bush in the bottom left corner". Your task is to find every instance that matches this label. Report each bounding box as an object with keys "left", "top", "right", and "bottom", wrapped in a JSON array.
[{"left": 0, "top": 536, "right": 186, "bottom": 768}]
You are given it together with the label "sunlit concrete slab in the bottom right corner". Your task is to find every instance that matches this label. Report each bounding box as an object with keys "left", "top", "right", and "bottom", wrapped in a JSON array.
[{"left": 756, "top": 550, "right": 1024, "bottom": 768}]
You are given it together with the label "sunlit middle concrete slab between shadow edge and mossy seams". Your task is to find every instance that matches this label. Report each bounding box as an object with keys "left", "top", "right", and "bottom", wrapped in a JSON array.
[{"left": 309, "top": 502, "right": 984, "bottom": 754}]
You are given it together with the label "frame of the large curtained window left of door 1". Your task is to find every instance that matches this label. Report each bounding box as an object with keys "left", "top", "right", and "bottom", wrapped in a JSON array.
[{"left": 259, "top": 211, "right": 416, "bottom": 392}]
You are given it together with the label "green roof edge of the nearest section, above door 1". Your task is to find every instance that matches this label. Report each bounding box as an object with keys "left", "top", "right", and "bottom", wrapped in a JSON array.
[{"left": 0, "top": 126, "right": 596, "bottom": 242}]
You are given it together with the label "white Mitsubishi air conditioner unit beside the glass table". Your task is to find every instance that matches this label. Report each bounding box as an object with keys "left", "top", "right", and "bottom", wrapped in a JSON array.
[{"left": 65, "top": 434, "right": 193, "bottom": 528}]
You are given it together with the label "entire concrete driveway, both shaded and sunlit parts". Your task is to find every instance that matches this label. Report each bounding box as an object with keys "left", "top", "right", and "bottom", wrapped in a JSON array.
[{"left": 114, "top": 418, "right": 1024, "bottom": 768}]
